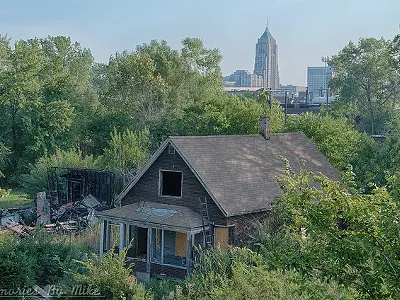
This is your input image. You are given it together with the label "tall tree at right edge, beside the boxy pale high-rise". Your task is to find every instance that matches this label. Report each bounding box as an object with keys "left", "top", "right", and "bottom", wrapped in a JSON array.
[{"left": 330, "top": 38, "right": 400, "bottom": 134}]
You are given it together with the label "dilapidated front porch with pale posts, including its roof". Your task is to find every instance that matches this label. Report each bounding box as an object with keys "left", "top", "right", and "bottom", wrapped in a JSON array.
[{"left": 98, "top": 202, "right": 204, "bottom": 280}]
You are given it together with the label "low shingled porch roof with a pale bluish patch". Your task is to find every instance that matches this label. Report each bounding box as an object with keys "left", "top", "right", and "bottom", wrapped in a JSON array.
[{"left": 96, "top": 201, "right": 202, "bottom": 233}]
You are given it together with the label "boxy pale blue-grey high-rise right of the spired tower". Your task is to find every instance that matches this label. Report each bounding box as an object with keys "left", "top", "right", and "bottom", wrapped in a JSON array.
[{"left": 307, "top": 67, "right": 332, "bottom": 98}]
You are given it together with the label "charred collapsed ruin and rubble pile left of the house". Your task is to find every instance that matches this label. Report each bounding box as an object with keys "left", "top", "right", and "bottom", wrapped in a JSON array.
[{"left": 0, "top": 168, "right": 115, "bottom": 235}]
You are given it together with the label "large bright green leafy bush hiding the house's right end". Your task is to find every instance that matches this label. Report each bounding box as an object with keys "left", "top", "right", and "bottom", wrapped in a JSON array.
[{"left": 260, "top": 161, "right": 400, "bottom": 299}]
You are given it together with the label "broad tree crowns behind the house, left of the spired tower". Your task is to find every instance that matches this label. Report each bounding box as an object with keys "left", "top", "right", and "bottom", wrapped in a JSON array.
[{"left": 98, "top": 38, "right": 223, "bottom": 128}]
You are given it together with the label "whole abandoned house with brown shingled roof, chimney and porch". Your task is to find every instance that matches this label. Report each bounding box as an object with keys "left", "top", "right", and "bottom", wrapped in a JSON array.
[{"left": 98, "top": 116, "right": 339, "bottom": 280}]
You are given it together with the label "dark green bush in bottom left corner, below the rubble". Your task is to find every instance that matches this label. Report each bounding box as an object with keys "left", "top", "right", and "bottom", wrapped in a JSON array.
[{"left": 0, "top": 231, "right": 85, "bottom": 288}]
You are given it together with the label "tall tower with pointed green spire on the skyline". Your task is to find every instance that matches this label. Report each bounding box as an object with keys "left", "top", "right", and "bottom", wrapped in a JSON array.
[{"left": 254, "top": 26, "right": 279, "bottom": 90}]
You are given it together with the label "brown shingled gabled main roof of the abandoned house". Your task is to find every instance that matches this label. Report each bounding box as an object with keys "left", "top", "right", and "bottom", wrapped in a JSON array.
[{"left": 117, "top": 132, "right": 340, "bottom": 217}]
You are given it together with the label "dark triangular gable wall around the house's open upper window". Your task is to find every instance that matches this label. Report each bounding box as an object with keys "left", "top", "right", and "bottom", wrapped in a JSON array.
[{"left": 121, "top": 147, "right": 226, "bottom": 225}]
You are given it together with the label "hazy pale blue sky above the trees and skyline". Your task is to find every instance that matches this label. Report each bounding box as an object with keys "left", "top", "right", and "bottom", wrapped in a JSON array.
[{"left": 0, "top": 0, "right": 400, "bottom": 85}]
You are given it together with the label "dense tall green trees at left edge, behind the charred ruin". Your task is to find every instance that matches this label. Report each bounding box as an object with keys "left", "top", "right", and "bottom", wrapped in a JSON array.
[{"left": 0, "top": 37, "right": 92, "bottom": 183}]
